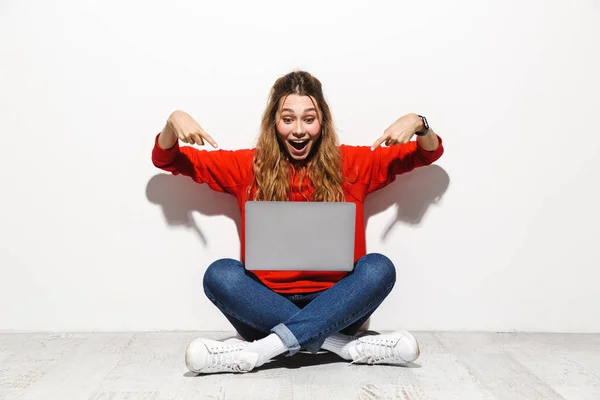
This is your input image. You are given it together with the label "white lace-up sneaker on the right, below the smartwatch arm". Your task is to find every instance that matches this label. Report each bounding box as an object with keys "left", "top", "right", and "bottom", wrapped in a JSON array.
[{"left": 349, "top": 331, "right": 421, "bottom": 365}]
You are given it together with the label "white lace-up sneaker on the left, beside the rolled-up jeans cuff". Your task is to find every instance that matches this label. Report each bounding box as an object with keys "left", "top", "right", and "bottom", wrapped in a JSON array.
[{"left": 185, "top": 338, "right": 258, "bottom": 374}]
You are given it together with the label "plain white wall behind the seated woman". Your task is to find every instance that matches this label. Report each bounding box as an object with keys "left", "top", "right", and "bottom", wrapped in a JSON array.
[{"left": 0, "top": 0, "right": 600, "bottom": 332}]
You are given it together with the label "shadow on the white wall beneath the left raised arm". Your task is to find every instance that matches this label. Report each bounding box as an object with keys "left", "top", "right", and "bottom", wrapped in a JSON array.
[{"left": 146, "top": 173, "right": 242, "bottom": 247}]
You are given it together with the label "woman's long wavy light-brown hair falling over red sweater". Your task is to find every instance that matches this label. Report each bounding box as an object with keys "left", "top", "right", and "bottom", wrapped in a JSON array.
[{"left": 248, "top": 71, "right": 344, "bottom": 202}]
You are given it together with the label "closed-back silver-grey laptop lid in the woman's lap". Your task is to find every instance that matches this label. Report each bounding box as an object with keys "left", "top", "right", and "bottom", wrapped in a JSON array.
[{"left": 245, "top": 201, "right": 356, "bottom": 271}]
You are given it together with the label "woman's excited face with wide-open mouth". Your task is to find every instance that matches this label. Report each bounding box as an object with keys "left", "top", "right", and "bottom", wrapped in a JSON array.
[{"left": 275, "top": 94, "right": 321, "bottom": 161}]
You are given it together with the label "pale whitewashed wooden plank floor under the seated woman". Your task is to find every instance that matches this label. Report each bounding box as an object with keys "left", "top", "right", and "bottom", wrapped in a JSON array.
[{"left": 0, "top": 332, "right": 600, "bottom": 400}]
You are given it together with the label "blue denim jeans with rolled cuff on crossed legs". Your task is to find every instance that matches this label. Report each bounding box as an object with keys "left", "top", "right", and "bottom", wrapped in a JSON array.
[{"left": 204, "top": 253, "right": 396, "bottom": 355}]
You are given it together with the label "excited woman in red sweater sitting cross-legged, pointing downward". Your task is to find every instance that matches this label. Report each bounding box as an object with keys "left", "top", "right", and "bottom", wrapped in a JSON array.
[{"left": 152, "top": 71, "right": 443, "bottom": 373}]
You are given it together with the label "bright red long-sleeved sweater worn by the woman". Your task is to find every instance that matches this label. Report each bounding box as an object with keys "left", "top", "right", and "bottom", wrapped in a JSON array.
[{"left": 152, "top": 136, "right": 444, "bottom": 293}]
